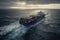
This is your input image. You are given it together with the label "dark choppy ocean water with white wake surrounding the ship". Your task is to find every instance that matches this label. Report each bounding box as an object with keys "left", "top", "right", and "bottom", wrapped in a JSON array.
[{"left": 0, "top": 9, "right": 60, "bottom": 40}]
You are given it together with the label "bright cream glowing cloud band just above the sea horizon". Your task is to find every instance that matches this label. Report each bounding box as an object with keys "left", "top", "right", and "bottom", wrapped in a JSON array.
[{"left": 10, "top": 4, "right": 60, "bottom": 9}]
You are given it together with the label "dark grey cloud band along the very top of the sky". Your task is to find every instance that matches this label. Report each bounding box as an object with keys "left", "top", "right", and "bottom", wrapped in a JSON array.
[{"left": 0, "top": 0, "right": 60, "bottom": 4}]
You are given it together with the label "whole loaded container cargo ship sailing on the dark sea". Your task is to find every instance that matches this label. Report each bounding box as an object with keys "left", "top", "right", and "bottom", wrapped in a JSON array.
[{"left": 19, "top": 11, "right": 45, "bottom": 26}]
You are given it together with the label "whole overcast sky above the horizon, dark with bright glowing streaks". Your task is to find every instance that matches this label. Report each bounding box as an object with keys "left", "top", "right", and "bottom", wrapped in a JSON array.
[{"left": 0, "top": 0, "right": 60, "bottom": 9}]
